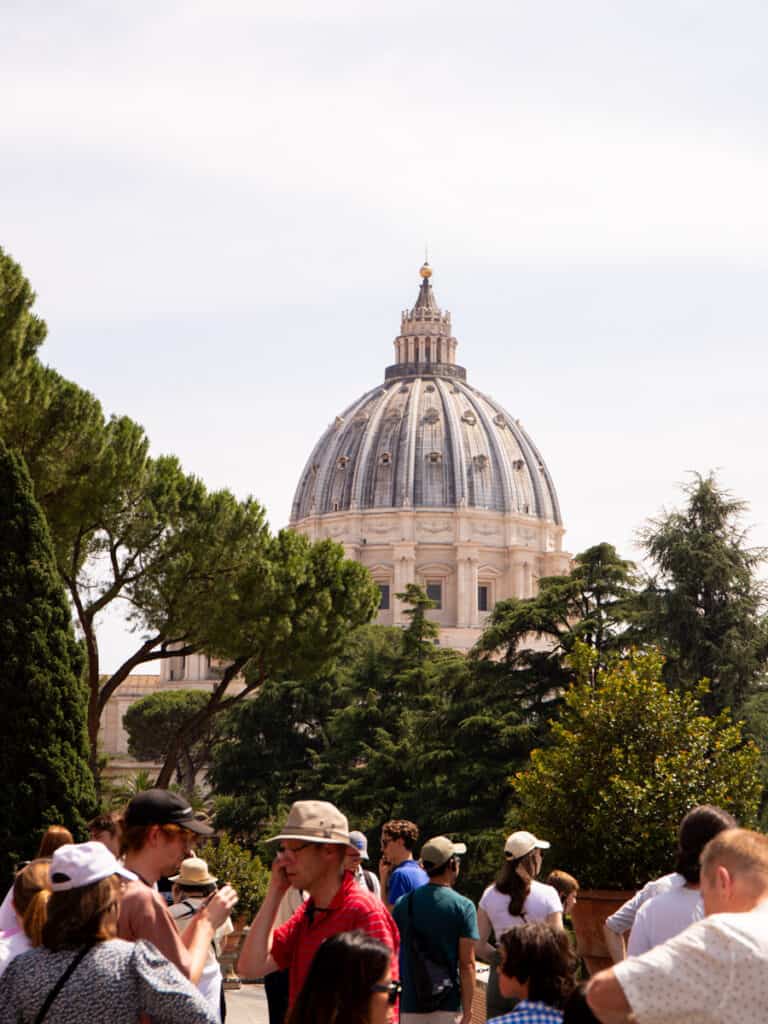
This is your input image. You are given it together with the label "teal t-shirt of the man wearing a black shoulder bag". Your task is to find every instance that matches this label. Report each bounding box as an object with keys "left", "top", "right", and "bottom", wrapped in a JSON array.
[{"left": 392, "top": 884, "right": 479, "bottom": 1014}]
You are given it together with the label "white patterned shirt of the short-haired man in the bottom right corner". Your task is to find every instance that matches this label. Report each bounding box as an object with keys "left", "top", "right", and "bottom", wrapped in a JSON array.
[{"left": 613, "top": 904, "right": 768, "bottom": 1024}]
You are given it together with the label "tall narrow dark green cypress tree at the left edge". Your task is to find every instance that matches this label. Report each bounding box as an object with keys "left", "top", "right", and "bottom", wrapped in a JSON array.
[{"left": 0, "top": 441, "right": 95, "bottom": 877}]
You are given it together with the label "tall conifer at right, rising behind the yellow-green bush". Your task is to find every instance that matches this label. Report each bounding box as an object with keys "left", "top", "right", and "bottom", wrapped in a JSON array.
[{"left": 640, "top": 474, "right": 768, "bottom": 714}]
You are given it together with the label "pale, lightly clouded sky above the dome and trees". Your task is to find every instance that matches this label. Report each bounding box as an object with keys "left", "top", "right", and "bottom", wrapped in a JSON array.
[{"left": 0, "top": 0, "right": 768, "bottom": 669}]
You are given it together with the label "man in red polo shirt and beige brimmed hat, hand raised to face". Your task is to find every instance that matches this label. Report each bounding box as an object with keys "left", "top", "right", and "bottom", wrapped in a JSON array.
[{"left": 238, "top": 800, "right": 399, "bottom": 1006}]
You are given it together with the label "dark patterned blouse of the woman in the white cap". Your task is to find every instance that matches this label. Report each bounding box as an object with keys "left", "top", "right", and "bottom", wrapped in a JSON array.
[{"left": 0, "top": 939, "right": 217, "bottom": 1024}]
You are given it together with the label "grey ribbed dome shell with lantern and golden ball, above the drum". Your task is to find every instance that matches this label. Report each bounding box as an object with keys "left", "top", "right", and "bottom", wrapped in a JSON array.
[{"left": 291, "top": 264, "right": 561, "bottom": 524}]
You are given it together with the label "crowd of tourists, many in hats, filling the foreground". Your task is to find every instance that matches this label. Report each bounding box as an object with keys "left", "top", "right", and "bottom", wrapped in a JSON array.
[{"left": 0, "top": 790, "right": 768, "bottom": 1024}]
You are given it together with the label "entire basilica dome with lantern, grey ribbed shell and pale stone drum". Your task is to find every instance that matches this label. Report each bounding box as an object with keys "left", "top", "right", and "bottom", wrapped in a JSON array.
[{"left": 291, "top": 264, "right": 569, "bottom": 649}]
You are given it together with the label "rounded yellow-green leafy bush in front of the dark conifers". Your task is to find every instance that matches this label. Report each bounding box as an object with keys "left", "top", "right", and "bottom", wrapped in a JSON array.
[{"left": 510, "top": 646, "right": 761, "bottom": 889}]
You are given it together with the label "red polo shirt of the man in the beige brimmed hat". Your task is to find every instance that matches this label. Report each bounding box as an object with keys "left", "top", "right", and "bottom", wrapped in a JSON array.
[{"left": 271, "top": 871, "right": 400, "bottom": 1006}]
